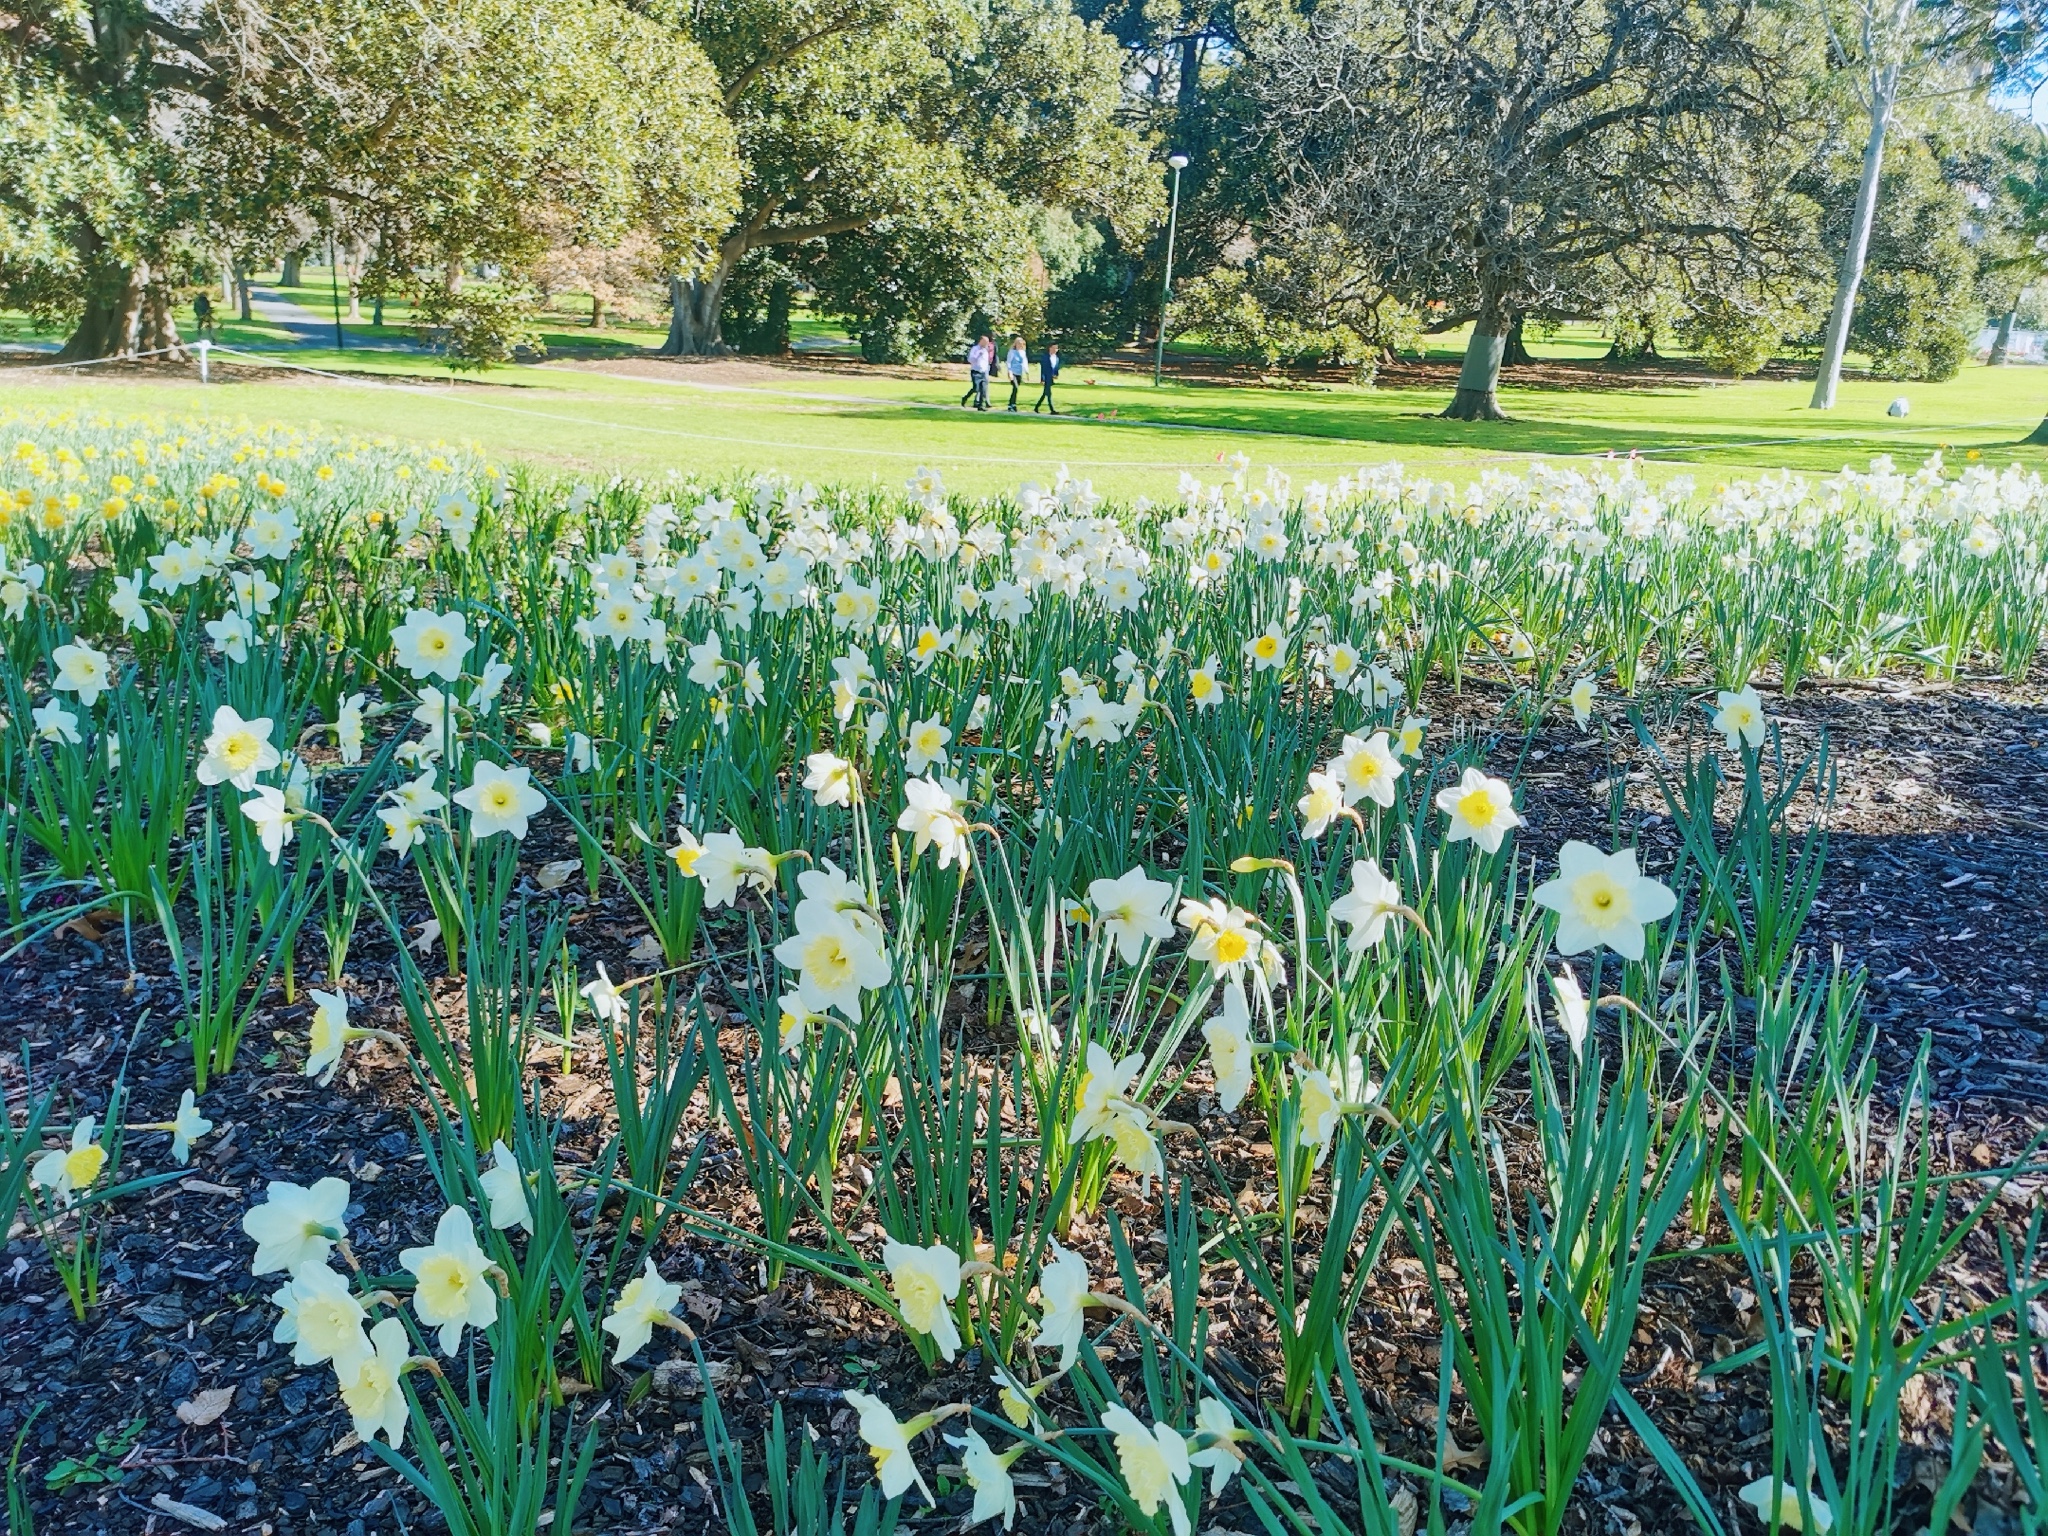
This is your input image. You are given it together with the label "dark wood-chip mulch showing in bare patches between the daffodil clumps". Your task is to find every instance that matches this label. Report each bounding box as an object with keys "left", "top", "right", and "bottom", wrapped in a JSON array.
[{"left": 0, "top": 684, "right": 2048, "bottom": 1536}]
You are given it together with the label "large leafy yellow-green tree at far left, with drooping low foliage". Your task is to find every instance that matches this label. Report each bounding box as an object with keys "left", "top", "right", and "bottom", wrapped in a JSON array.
[{"left": 0, "top": 0, "right": 737, "bottom": 356}]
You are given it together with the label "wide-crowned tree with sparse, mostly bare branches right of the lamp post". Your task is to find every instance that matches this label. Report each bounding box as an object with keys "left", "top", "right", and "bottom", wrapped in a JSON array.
[{"left": 1243, "top": 0, "right": 1798, "bottom": 420}]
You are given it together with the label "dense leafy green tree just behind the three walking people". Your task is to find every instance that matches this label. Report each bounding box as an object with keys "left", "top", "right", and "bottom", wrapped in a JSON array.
[{"left": 651, "top": 0, "right": 1157, "bottom": 354}]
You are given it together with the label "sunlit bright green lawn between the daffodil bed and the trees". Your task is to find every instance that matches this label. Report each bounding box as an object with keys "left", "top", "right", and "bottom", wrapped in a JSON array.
[{"left": 0, "top": 309, "right": 2048, "bottom": 496}]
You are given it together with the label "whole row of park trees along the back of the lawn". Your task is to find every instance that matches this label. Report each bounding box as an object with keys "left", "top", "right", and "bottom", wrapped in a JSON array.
[{"left": 0, "top": 0, "right": 2048, "bottom": 418}]
